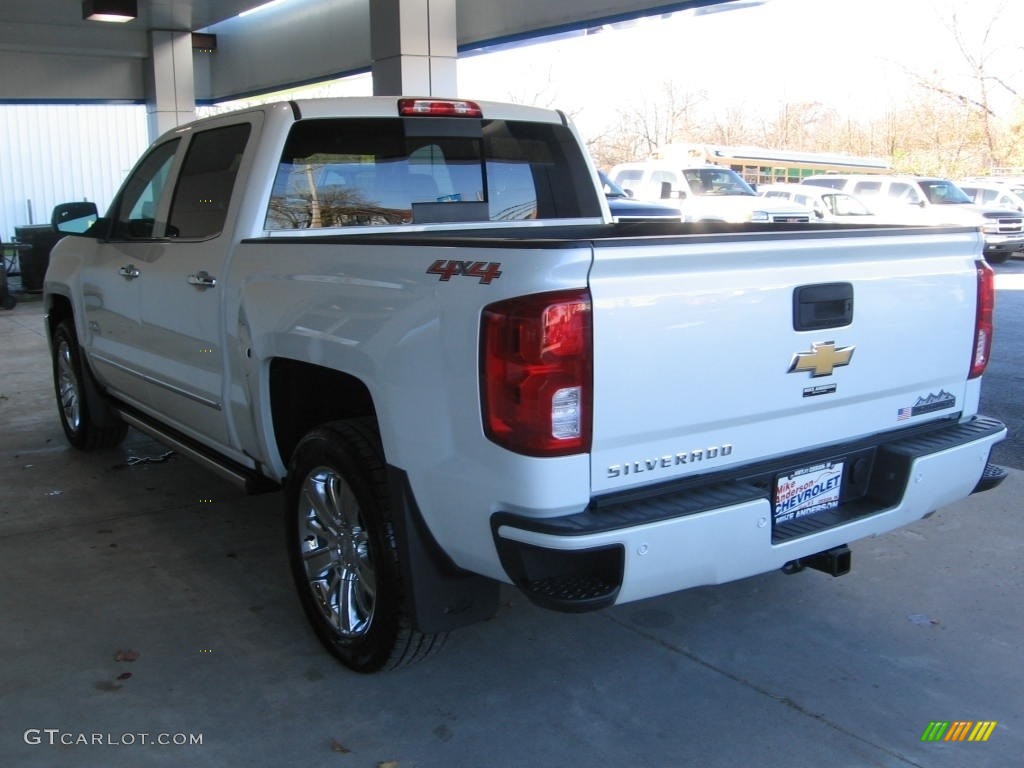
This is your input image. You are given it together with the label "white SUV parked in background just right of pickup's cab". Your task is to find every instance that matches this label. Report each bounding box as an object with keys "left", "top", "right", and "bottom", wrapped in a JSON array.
[{"left": 608, "top": 161, "right": 811, "bottom": 223}]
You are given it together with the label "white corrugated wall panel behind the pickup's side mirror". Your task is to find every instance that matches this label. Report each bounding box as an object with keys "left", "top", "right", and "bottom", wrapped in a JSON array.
[{"left": 0, "top": 104, "right": 150, "bottom": 241}]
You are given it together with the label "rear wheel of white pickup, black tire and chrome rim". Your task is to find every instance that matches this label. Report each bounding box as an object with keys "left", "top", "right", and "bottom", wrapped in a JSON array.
[{"left": 285, "top": 419, "right": 445, "bottom": 673}]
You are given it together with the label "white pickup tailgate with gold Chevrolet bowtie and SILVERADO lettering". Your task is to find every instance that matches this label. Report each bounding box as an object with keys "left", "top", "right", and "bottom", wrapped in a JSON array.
[{"left": 590, "top": 229, "right": 982, "bottom": 495}]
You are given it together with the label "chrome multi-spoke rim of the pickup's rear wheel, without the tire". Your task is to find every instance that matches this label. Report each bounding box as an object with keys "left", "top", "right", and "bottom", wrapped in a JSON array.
[{"left": 297, "top": 466, "right": 377, "bottom": 638}]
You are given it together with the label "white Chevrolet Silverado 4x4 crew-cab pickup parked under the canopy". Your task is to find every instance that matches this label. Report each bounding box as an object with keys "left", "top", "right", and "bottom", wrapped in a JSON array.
[{"left": 45, "top": 97, "right": 1006, "bottom": 672}]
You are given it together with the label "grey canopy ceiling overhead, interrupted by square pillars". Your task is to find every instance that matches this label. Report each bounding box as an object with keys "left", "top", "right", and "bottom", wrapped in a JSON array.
[{"left": 0, "top": 0, "right": 741, "bottom": 102}]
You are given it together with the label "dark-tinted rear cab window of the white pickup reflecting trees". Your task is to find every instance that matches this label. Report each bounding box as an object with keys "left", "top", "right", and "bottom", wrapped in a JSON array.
[{"left": 264, "top": 118, "right": 601, "bottom": 230}]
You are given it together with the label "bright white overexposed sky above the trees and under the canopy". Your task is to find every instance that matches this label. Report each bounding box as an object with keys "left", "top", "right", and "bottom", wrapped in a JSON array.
[{"left": 216, "top": 0, "right": 1024, "bottom": 144}]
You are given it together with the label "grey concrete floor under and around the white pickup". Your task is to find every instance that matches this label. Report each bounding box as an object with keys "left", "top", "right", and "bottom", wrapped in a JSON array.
[{"left": 0, "top": 299, "right": 1024, "bottom": 768}]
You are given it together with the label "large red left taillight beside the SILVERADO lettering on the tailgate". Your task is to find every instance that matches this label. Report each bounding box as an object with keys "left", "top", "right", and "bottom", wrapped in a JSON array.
[{"left": 480, "top": 290, "right": 592, "bottom": 456}]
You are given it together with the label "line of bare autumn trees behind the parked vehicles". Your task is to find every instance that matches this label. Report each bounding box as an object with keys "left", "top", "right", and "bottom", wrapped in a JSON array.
[{"left": 590, "top": 0, "right": 1024, "bottom": 177}]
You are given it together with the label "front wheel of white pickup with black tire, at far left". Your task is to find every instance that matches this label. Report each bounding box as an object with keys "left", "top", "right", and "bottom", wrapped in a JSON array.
[{"left": 53, "top": 319, "right": 128, "bottom": 451}]
